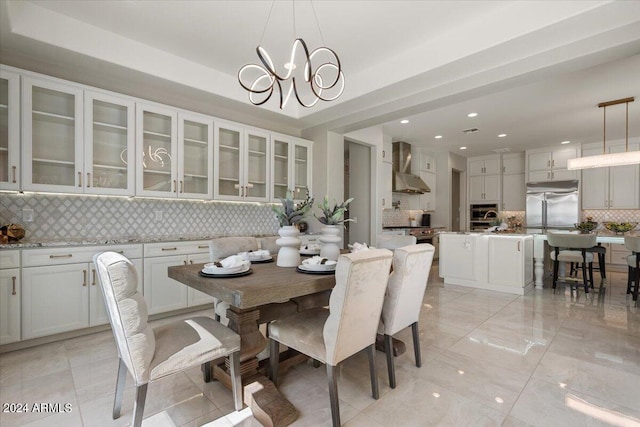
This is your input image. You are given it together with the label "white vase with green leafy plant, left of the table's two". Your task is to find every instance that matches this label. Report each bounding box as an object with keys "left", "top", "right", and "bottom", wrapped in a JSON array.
[{"left": 271, "top": 189, "right": 313, "bottom": 267}]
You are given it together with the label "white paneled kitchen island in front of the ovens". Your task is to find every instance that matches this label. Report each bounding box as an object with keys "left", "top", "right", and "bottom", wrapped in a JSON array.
[{"left": 440, "top": 232, "right": 534, "bottom": 295}]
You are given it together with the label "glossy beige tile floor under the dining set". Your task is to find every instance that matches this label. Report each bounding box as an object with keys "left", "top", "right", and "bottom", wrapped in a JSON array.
[{"left": 0, "top": 265, "right": 640, "bottom": 427}]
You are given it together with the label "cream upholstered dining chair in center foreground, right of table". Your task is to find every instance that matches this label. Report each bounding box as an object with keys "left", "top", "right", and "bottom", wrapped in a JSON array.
[{"left": 269, "top": 249, "right": 392, "bottom": 426}]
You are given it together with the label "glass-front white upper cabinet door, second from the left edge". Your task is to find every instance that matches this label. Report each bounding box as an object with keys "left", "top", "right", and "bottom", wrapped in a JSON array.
[{"left": 21, "top": 77, "right": 84, "bottom": 193}]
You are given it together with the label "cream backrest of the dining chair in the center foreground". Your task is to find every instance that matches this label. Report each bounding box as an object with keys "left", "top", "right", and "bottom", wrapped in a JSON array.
[{"left": 323, "top": 249, "right": 393, "bottom": 366}]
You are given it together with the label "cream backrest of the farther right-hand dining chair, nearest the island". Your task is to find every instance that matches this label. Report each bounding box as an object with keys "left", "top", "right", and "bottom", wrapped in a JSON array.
[{"left": 379, "top": 243, "right": 435, "bottom": 335}]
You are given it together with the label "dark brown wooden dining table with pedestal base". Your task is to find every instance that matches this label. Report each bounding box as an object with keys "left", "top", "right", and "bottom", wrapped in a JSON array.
[{"left": 169, "top": 257, "right": 335, "bottom": 426}]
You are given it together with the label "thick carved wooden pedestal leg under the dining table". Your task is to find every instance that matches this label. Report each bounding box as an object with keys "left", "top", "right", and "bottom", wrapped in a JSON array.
[{"left": 213, "top": 307, "right": 298, "bottom": 427}]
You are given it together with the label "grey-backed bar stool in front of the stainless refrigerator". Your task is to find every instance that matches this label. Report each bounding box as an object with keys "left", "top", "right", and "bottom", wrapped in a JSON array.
[{"left": 547, "top": 232, "right": 597, "bottom": 293}]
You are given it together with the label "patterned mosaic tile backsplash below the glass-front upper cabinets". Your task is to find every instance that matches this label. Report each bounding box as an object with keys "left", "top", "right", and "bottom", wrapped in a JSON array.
[{"left": 0, "top": 194, "right": 279, "bottom": 242}]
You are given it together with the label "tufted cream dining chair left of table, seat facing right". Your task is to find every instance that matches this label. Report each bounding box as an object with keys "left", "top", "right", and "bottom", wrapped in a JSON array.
[{"left": 93, "top": 252, "right": 242, "bottom": 427}]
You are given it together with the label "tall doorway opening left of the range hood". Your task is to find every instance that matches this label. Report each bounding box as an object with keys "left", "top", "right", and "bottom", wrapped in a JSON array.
[{"left": 344, "top": 140, "right": 372, "bottom": 243}]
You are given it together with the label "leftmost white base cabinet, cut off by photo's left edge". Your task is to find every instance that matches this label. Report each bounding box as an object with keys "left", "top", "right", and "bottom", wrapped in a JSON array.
[{"left": 0, "top": 250, "right": 22, "bottom": 345}]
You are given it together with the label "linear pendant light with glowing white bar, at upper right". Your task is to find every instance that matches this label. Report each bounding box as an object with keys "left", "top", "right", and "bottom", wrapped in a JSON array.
[{"left": 567, "top": 97, "right": 640, "bottom": 170}]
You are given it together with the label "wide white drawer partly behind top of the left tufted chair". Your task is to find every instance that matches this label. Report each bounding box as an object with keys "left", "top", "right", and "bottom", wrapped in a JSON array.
[{"left": 22, "top": 245, "right": 142, "bottom": 267}]
